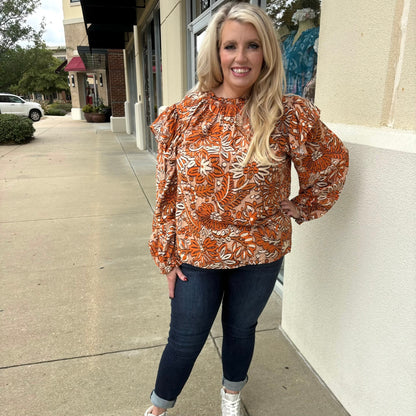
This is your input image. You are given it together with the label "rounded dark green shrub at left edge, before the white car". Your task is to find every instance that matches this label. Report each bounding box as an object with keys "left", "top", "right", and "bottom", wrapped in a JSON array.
[{"left": 0, "top": 114, "right": 35, "bottom": 144}]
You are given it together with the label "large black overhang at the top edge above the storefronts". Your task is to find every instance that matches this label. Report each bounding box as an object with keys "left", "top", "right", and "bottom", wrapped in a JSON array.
[{"left": 81, "top": 0, "right": 146, "bottom": 49}]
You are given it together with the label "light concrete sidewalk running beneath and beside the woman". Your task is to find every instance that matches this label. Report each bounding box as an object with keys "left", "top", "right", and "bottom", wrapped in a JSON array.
[{"left": 0, "top": 116, "right": 347, "bottom": 416}]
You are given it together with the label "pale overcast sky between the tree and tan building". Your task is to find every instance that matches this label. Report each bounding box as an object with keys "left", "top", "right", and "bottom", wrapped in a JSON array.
[{"left": 27, "top": 0, "right": 65, "bottom": 46}]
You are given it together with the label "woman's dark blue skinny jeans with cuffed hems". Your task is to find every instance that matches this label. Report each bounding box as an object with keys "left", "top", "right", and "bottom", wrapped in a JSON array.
[{"left": 151, "top": 259, "right": 283, "bottom": 409}]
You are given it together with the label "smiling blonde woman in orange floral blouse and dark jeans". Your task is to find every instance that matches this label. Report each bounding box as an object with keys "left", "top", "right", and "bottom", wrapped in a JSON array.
[{"left": 145, "top": 3, "right": 348, "bottom": 416}]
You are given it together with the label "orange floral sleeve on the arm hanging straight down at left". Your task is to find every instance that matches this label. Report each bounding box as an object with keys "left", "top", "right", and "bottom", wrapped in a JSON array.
[{"left": 149, "top": 105, "right": 180, "bottom": 274}]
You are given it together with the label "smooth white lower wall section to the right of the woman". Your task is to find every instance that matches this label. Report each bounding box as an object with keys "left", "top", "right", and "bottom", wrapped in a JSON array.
[{"left": 282, "top": 134, "right": 416, "bottom": 416}]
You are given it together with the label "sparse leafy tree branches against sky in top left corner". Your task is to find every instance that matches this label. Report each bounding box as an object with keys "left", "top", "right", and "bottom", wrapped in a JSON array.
[{"left": 0, "top": 0, "right": 45, "bottom": 56}]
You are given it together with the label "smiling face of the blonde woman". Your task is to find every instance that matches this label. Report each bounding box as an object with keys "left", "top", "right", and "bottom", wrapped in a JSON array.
[{"left": 217, "top": 20, "right": 263, "bottom": 98}]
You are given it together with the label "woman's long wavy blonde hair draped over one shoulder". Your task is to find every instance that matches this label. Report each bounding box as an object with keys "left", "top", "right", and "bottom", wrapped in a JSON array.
[{"left": 194, "top": 2, "right": 285, "bottom": 165}]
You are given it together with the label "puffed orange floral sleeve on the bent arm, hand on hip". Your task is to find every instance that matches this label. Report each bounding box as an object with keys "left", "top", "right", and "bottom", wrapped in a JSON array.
[{"left": 289, "top": 96, "right": 349, "bottom": 224}]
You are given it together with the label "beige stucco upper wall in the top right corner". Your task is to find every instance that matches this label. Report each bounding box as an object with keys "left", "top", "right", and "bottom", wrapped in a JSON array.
[{"left": 316, "top": 0, "right": 416, "bottom": 129}]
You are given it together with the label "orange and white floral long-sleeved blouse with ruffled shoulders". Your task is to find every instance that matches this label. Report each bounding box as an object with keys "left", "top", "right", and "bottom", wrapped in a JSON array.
[{"left": 149, "top": 92, "right": 348, "bottom": 274}]
